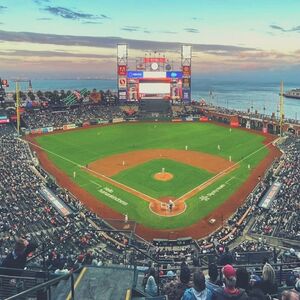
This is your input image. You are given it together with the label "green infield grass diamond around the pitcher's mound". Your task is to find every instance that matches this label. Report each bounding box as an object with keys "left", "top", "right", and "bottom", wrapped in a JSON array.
[{"left": 112, "top": 159, "right": 213, "bottom": 198}]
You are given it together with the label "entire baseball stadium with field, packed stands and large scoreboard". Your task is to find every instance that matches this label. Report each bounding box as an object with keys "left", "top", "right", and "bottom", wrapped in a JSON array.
[{"left": 0, "top": 44, "right": 300, "bottom": 300}]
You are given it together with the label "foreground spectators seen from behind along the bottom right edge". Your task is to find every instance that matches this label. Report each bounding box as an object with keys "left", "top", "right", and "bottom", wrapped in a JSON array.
[{"left": 157, "top": 259, "right": 300, "bottom": 300}]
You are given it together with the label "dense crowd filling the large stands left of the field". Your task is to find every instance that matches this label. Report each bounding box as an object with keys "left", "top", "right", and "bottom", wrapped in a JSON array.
[{"left": 0, "top": 126, "right": 139, "bottom": 270}]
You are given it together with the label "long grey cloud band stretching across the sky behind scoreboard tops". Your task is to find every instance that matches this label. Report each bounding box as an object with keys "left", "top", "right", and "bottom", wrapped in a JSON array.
[{"left": 0, "top": 30, "right": 256, "bottom": 53}]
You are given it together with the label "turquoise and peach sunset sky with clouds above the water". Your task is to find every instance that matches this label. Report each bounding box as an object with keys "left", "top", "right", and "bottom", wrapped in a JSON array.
[{"left": 0, "top": 0, "right": 300, "bottom": 79}]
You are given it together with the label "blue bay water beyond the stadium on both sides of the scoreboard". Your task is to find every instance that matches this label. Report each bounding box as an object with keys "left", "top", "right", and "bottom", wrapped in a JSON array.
[{"left": 9, "top": 77, "right": 300, "bottom": 120}]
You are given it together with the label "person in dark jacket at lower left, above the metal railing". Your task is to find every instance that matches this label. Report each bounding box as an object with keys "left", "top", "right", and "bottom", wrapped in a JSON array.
[{"left": 1, "top": 238, "right": 37, "bottom": 269}]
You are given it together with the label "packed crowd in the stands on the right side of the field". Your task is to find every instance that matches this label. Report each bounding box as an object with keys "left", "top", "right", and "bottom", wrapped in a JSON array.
[{"left": 252, "top": 138, "right": 300, "bottom": 241}]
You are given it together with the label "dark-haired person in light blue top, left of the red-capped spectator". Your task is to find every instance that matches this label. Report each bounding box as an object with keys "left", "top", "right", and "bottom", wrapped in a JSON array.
[{"left": 182, "top": 269, "right": 213, "bottom": 300}]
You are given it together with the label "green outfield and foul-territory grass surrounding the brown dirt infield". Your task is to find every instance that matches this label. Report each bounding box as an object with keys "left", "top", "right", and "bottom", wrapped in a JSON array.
[{"left": 37, "top": 123, "right": 268, "bottom": 229}]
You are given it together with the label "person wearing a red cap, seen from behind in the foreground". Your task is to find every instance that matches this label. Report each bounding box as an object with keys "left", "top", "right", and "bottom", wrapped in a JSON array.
[{"left": 214, "top": 265, "right": 248, "bottom": 300}]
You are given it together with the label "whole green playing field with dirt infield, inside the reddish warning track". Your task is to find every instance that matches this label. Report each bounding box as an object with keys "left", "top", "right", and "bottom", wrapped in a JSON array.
[{"left": 35, "top": 123, "right": 269, "bottom": 234}]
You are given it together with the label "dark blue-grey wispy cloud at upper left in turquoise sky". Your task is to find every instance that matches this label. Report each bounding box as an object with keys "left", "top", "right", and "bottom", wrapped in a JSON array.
[{"left": 42, "top": 6, "right": 109, "bottom": 21}]
